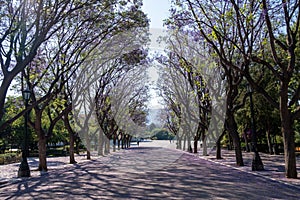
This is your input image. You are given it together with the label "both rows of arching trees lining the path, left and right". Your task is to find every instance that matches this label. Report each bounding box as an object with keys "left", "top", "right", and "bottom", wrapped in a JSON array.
[{"left": 0, "top": 0, "right": 300, "bottom": 178}]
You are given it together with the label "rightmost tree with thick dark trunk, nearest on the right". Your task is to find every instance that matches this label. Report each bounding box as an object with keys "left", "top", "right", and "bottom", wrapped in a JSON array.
[{"left": 233, "top": 0, "right": 300, "bottom": 178}]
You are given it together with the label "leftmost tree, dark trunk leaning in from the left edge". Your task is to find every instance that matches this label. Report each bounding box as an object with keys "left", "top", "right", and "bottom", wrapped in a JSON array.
[{"left": 0, "top": 0, "right": 108, "bottom": 119}]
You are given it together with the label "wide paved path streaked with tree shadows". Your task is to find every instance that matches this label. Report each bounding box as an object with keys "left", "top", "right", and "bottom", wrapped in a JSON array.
[{"left": 0, "top": 143, "right": 300, "bottom": 199}]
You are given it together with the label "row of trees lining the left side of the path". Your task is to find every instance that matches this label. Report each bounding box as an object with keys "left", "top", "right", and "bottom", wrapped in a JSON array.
[{"left": 0, "top": 0, "right": 148, "bottom": 170}]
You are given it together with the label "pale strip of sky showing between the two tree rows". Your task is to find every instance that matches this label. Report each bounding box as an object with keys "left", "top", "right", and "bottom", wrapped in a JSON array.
[{"left": 143, "top": 0, "right": 170, "bottom": 109}]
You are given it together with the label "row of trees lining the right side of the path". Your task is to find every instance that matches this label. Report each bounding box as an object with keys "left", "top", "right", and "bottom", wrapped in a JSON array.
[{"left": 158, "top": 0, "right": 300, "bottom": 178}]
